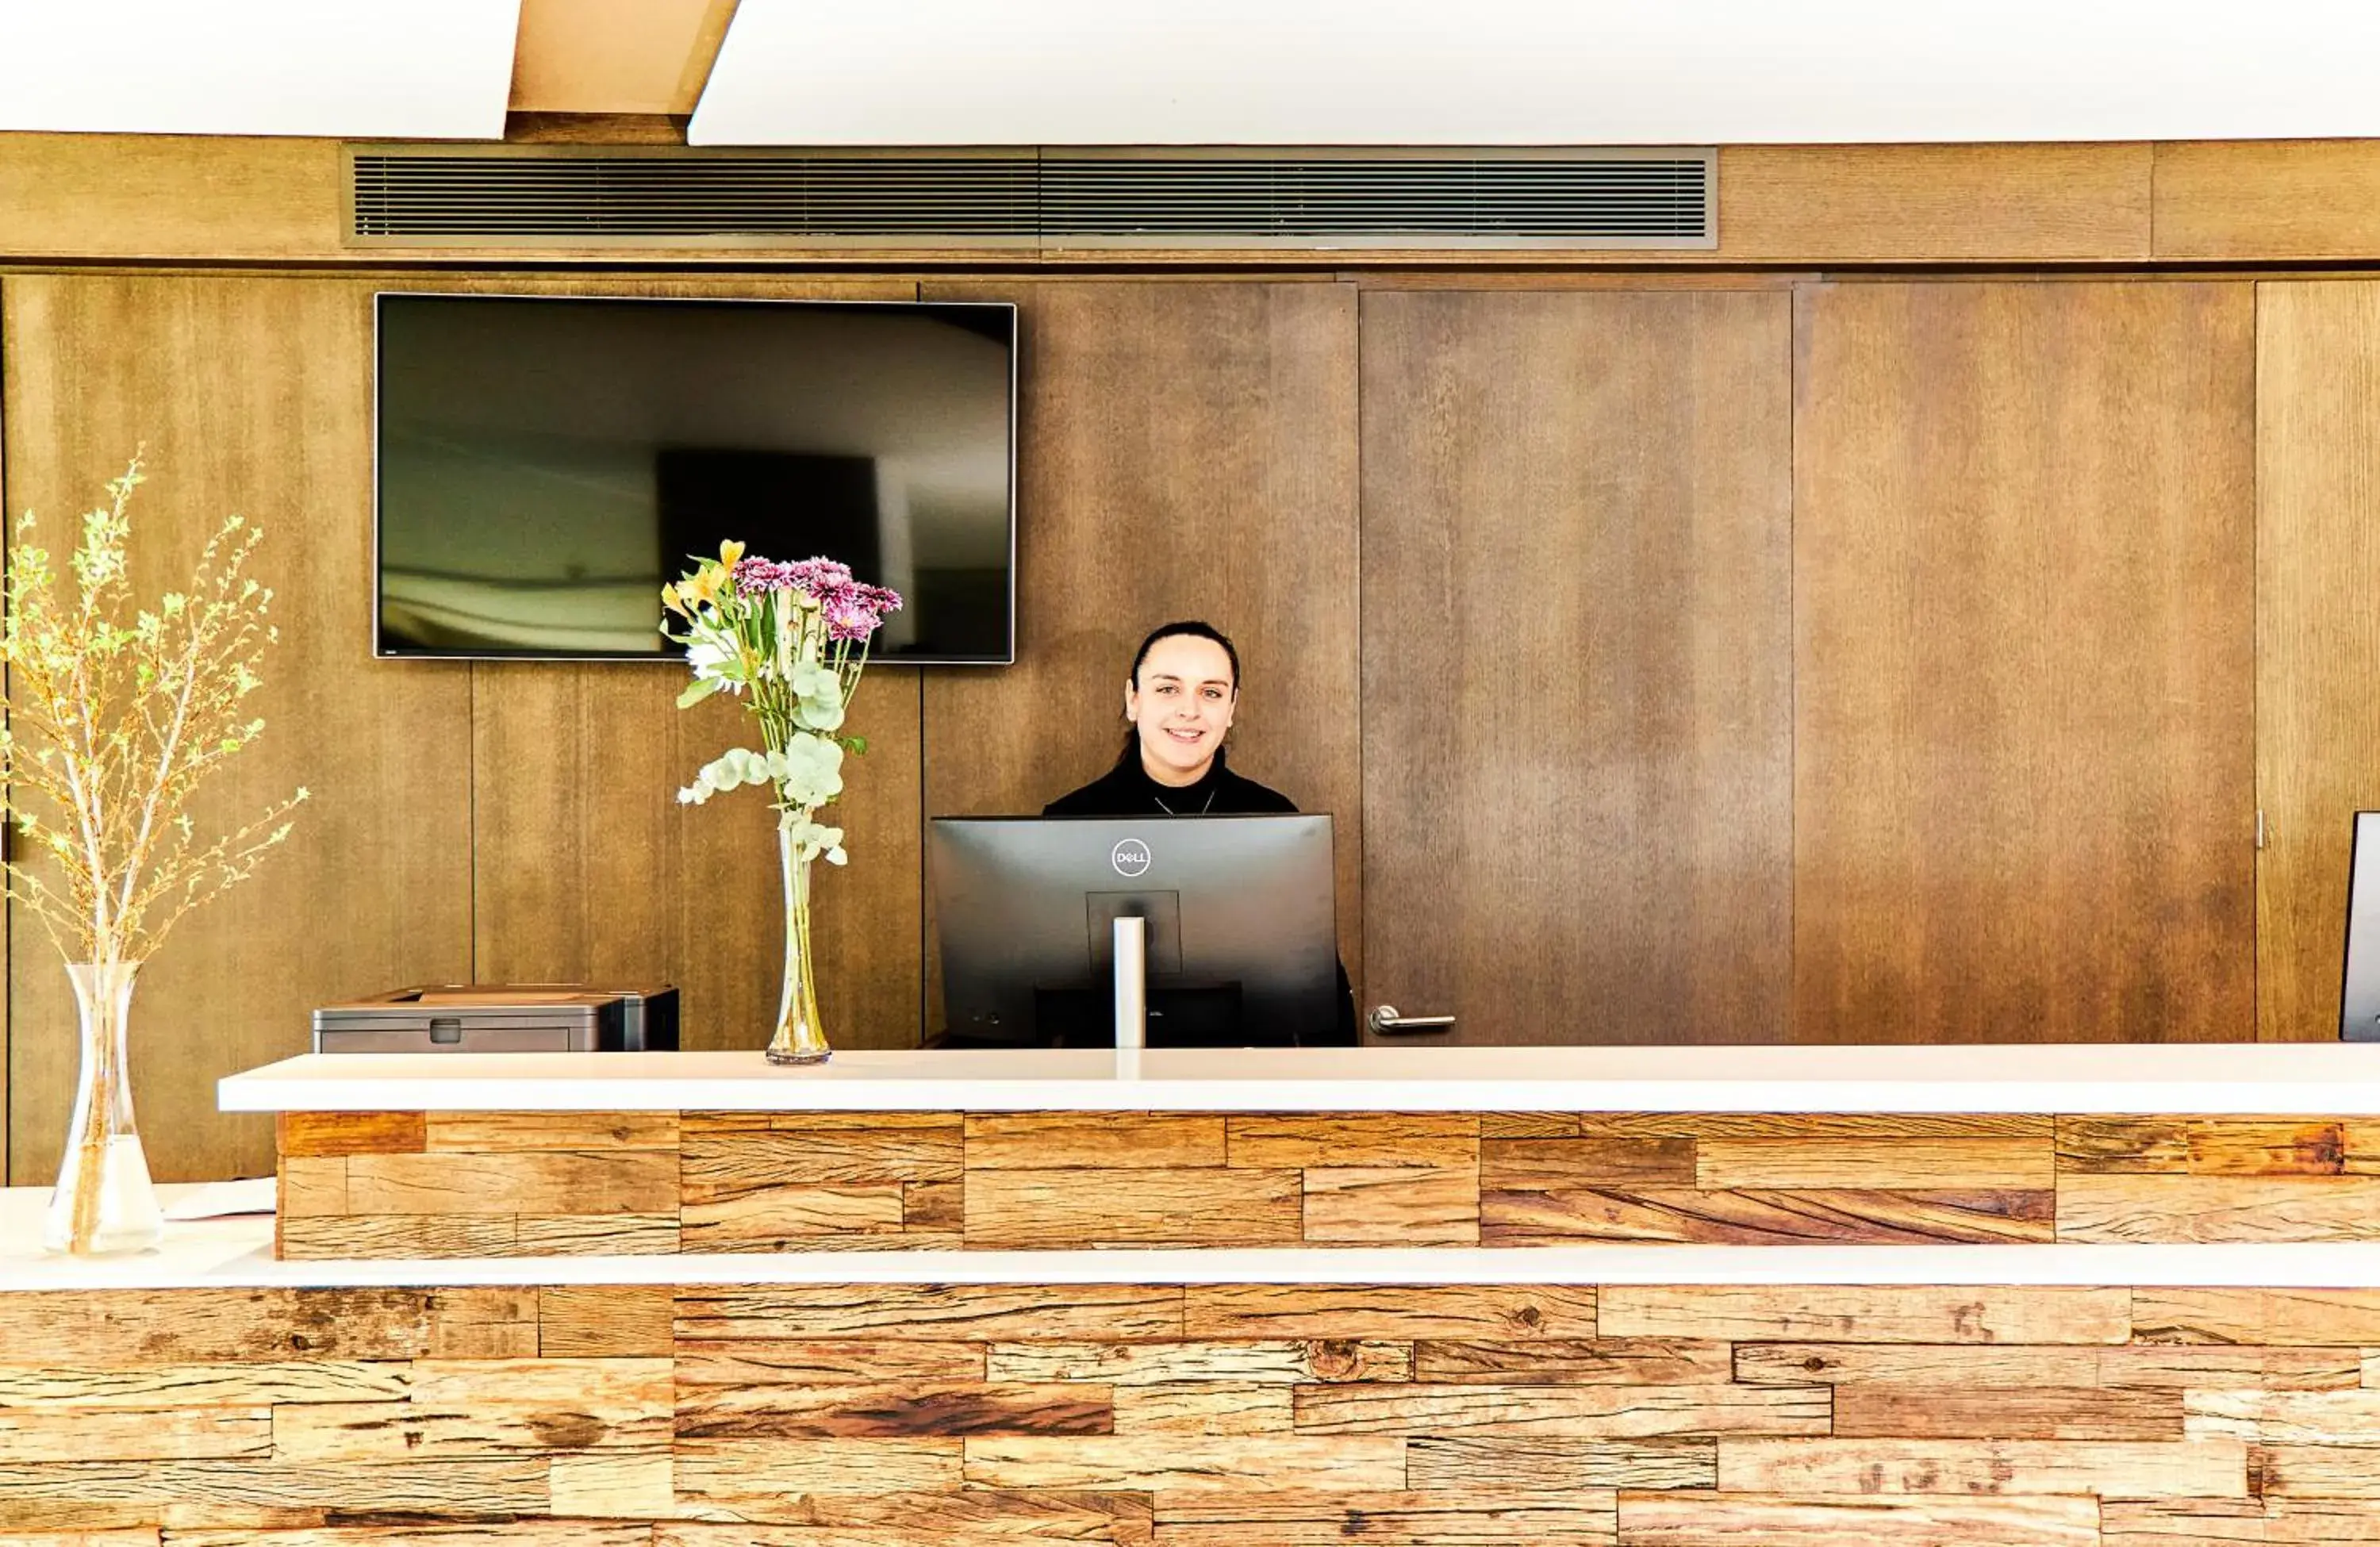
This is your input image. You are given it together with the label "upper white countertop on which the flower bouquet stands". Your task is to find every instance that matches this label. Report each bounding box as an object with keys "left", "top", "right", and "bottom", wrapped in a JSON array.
[{"left": 219, "top": 1042, "right": 2380, "bottom": 1116}]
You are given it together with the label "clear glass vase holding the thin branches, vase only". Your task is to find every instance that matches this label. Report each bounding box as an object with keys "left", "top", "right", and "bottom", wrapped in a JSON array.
[{"left": 40, "top": 962, "right": 164, "bottom": 1257}]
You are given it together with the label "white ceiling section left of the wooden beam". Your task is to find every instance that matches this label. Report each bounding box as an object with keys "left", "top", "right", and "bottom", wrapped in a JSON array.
[{"left": 0, "top": 0, "right": 521, "bottom": 140}]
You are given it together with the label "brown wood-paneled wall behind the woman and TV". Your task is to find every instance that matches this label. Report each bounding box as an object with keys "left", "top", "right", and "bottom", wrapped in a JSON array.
[{"left": 13, "top": 274, "right": 2380, "bottom": 1180}]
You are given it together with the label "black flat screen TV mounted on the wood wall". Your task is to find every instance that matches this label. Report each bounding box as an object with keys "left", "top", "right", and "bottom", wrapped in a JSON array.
[{"left": 374, "top": 293, "right": 1016, "bottom": 666}]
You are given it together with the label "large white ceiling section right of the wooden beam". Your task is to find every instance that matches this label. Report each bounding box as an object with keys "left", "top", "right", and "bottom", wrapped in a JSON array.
[{"left": 688, "top": 0, "right": 2380, "bottom": 145}]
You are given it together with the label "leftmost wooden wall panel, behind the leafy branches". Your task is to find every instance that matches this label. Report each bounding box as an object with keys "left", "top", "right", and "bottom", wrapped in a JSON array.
[{"left": 0, "top": 274, "right": 474, "bottom": 1180}]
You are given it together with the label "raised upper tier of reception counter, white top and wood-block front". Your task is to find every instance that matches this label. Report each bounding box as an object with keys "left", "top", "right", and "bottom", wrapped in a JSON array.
[{"left": 224, "top": 1045, "right": 2380, "bottom": 1259}]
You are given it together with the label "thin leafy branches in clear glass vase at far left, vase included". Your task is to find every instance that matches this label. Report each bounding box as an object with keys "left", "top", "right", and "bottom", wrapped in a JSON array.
[{"left": 0, "top": 457, "right": 307, "bottom": 1257}]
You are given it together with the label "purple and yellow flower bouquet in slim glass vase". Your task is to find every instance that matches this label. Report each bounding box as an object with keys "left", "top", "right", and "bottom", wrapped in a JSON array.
[{"left": 662, "top": 543, "right": 902, "bottom": 1064}]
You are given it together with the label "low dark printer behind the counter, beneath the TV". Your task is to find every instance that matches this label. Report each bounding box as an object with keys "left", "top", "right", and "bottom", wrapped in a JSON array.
[{"left": 314, "top": 983, "right": 678, "bottom": 1052}]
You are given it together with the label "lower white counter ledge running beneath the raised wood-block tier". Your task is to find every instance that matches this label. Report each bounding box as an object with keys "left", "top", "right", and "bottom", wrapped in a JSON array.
[{"left": 0, "top": 1188, "right": 2380, "bottom": 1292}]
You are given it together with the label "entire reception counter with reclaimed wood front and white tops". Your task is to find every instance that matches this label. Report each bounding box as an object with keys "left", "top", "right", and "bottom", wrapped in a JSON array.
[{"left": 13, "top": 1047, "right": 2380, "bottom": 1547}]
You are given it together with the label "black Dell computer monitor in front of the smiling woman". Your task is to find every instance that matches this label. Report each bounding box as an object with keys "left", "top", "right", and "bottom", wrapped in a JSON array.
[{"left": 931, "top": 816, "right": 1338, "bottom": 1047}]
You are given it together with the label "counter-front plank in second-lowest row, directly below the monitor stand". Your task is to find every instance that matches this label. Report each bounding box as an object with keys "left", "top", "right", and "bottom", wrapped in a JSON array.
[{"left": 966, "top": 1433, "right": 1404, "bottom": 1492}]
